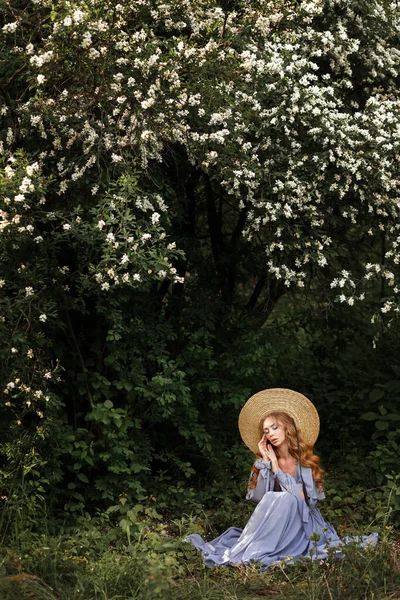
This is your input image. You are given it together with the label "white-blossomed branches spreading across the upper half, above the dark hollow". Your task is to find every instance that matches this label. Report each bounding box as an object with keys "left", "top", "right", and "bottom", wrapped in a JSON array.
[{"left": 0, "top": 0, "right": 400, "bottom": 424}]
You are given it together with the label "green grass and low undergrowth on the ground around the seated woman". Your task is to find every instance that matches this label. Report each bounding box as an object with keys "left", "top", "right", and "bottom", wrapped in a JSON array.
[{"left": 0, "top": 480, "right": 400, "bottom": 600}]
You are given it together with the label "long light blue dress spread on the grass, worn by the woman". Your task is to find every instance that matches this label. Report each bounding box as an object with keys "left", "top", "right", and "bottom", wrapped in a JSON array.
[{"left": 186, "top": 459, "right": 377, "bottom": 568}]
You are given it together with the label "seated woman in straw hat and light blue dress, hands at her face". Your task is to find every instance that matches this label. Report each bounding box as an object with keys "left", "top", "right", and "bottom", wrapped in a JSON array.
[{"left": 187, "top": 388, "right": 377, "bottom": 567}]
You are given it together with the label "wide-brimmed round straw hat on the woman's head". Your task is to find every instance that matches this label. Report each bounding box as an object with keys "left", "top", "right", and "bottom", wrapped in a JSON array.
[{"left": 239, "top": 388, "right": 319, "bottom": 454}]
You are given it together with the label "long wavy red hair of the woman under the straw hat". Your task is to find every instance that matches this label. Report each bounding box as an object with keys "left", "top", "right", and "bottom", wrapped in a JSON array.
[{"left": 249, "top": 411, "right": 324, "bottom": 489}]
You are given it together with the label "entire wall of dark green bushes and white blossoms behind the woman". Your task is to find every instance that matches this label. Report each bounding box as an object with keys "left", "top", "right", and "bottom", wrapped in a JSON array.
[{"left": 0, "top": 0, "right": 400, "bottom": 524}]
